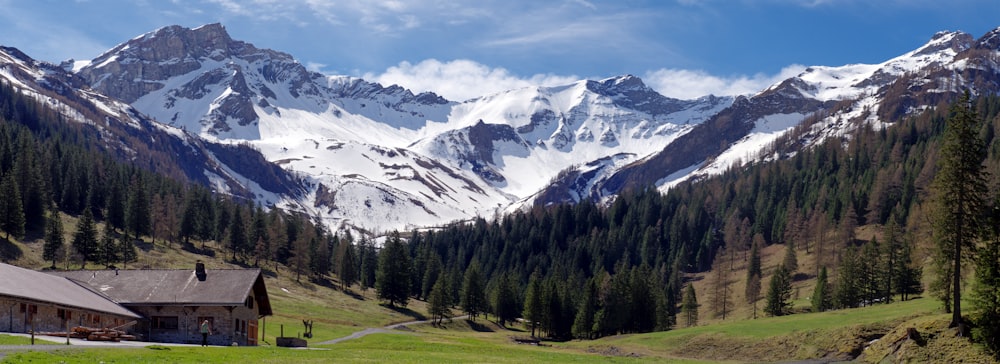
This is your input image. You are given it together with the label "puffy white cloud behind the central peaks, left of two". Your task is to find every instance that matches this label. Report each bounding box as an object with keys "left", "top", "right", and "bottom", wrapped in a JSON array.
[{"left": 364, "top": 59, "right": 580, "bottom": 101}]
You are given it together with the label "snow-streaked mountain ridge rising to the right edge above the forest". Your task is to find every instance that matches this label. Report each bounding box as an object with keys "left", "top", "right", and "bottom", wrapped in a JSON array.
[{"left": 580, "top": 28, "right": 1000, "bottom": 196}]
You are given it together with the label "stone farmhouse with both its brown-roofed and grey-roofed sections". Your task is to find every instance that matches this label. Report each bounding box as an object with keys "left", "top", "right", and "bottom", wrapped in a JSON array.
[{"left": 0, "top": 263, "right": 272, "bottom": 346}]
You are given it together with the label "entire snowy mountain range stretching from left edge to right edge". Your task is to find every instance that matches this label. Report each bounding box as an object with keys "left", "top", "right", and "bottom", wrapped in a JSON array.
[{"left": 0, "top": 24, "right": 1000, "bottom": 233}]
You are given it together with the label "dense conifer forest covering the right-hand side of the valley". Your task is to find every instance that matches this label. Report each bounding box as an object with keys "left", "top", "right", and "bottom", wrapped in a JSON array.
[{"left": 356, "top": 96, "right": 1000, "bottom": 339}]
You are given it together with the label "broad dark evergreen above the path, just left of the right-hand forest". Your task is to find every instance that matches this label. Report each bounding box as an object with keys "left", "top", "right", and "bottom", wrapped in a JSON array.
[{"left": 375, "top": 232, "right": 411, "bottom": 307}]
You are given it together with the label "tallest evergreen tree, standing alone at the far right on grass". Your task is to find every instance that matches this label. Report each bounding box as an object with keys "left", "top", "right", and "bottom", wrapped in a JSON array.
[{"left": 933, "top": 91, "right": 987, "bottom": 327}]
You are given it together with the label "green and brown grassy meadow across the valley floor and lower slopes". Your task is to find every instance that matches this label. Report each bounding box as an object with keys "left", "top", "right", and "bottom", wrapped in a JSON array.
[{"left": 4, "top": 217, "right": 991, "bottom": 363}]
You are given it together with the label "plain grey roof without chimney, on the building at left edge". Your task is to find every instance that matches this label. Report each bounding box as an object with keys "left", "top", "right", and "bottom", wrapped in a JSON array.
[{"left": 0, "top": 263, "right": 141, "bottom": 318}]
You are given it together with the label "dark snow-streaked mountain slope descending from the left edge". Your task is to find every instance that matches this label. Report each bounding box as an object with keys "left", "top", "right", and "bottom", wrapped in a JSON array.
[{"left": 0, "top": 47, "right": 306, "bottom": 200}]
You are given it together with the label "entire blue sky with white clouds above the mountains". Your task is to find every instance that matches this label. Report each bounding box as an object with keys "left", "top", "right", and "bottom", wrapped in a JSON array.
[{"left": 0, "top": 0, "right": 1000, "bottom": 100}]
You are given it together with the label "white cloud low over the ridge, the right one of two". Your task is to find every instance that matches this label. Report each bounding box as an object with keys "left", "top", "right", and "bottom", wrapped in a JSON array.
[{"left": 643, "top": 65, "right": 805, "bottom": 99}]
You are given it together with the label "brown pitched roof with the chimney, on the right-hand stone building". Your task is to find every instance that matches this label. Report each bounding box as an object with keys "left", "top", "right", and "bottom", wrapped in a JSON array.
[{"left": 50, "top": 269, "right": 272, "bottom": 316}]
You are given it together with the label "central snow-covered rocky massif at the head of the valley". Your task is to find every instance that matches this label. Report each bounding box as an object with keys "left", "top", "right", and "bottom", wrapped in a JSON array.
[{"left": 68, "top": 24, "right": 732, "bottom": 231}]
